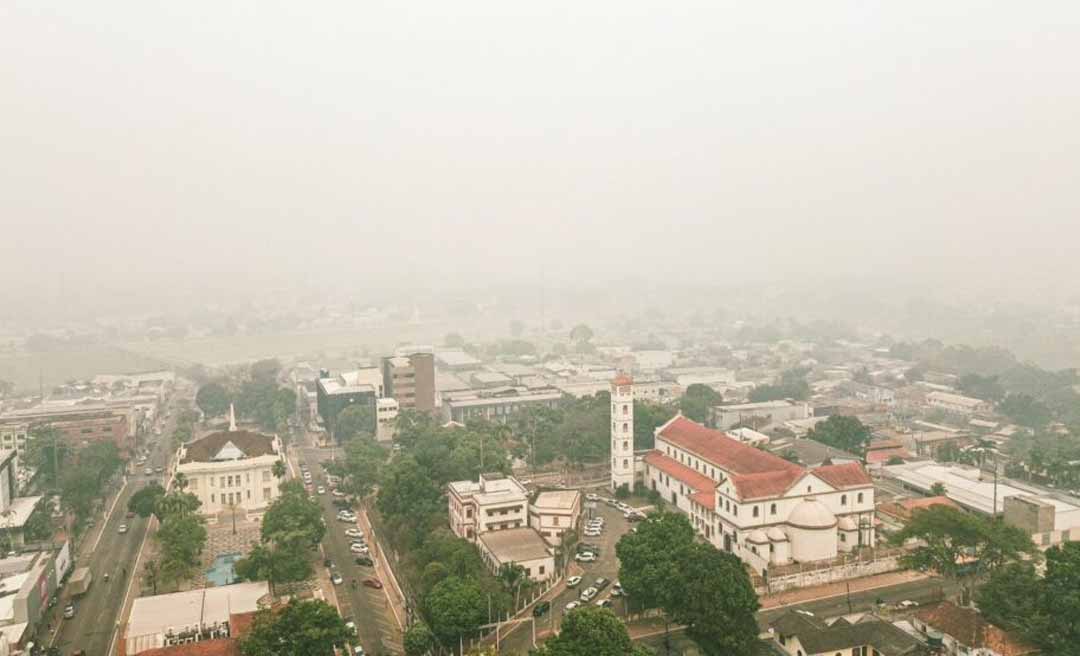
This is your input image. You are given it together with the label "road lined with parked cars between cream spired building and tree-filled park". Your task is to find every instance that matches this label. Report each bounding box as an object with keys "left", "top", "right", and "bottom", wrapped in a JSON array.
[{"left": 294, "top": 446, "right": 404, "bottom": 654}]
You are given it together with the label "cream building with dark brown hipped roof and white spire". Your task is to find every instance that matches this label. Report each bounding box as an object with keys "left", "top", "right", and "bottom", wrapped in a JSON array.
[{"left": 176, "top": 412, "right": 284, "bottom": 516}]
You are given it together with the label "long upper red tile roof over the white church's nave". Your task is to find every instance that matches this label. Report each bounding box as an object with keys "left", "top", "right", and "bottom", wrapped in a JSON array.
[{"left": 660, "top": 416, "right": 804, "bottom": 474}]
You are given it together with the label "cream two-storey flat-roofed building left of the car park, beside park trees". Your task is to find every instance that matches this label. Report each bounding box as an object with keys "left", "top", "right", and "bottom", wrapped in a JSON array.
[{"left": 447, "top": 473, "right": 529, "bottom": 541}]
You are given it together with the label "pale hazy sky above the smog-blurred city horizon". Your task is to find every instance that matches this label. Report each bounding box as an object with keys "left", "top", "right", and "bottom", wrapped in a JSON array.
[{"left": 0, "top": 0, "right": 1080, "bottom": 296}]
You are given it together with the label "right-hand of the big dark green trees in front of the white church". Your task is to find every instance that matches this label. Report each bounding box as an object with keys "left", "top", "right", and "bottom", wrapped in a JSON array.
[{"left": 664, "top": 543, "right": 759, "bottom": 656}]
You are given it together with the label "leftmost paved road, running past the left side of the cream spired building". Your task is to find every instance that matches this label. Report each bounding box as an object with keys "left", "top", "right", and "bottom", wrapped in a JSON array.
[{"left": 52, "top": 391, "right": 190, "bottom": 655}]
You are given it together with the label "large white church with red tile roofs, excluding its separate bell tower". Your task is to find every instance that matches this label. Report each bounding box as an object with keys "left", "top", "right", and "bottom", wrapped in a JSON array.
[{"left": 639, "top": 411, "right": 875, "bottom": 573}]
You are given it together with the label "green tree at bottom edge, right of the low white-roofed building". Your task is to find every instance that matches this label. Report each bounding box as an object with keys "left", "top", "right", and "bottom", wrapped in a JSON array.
[{"left": 240, "top": 599, "right": 352, "bottom": 656}]
